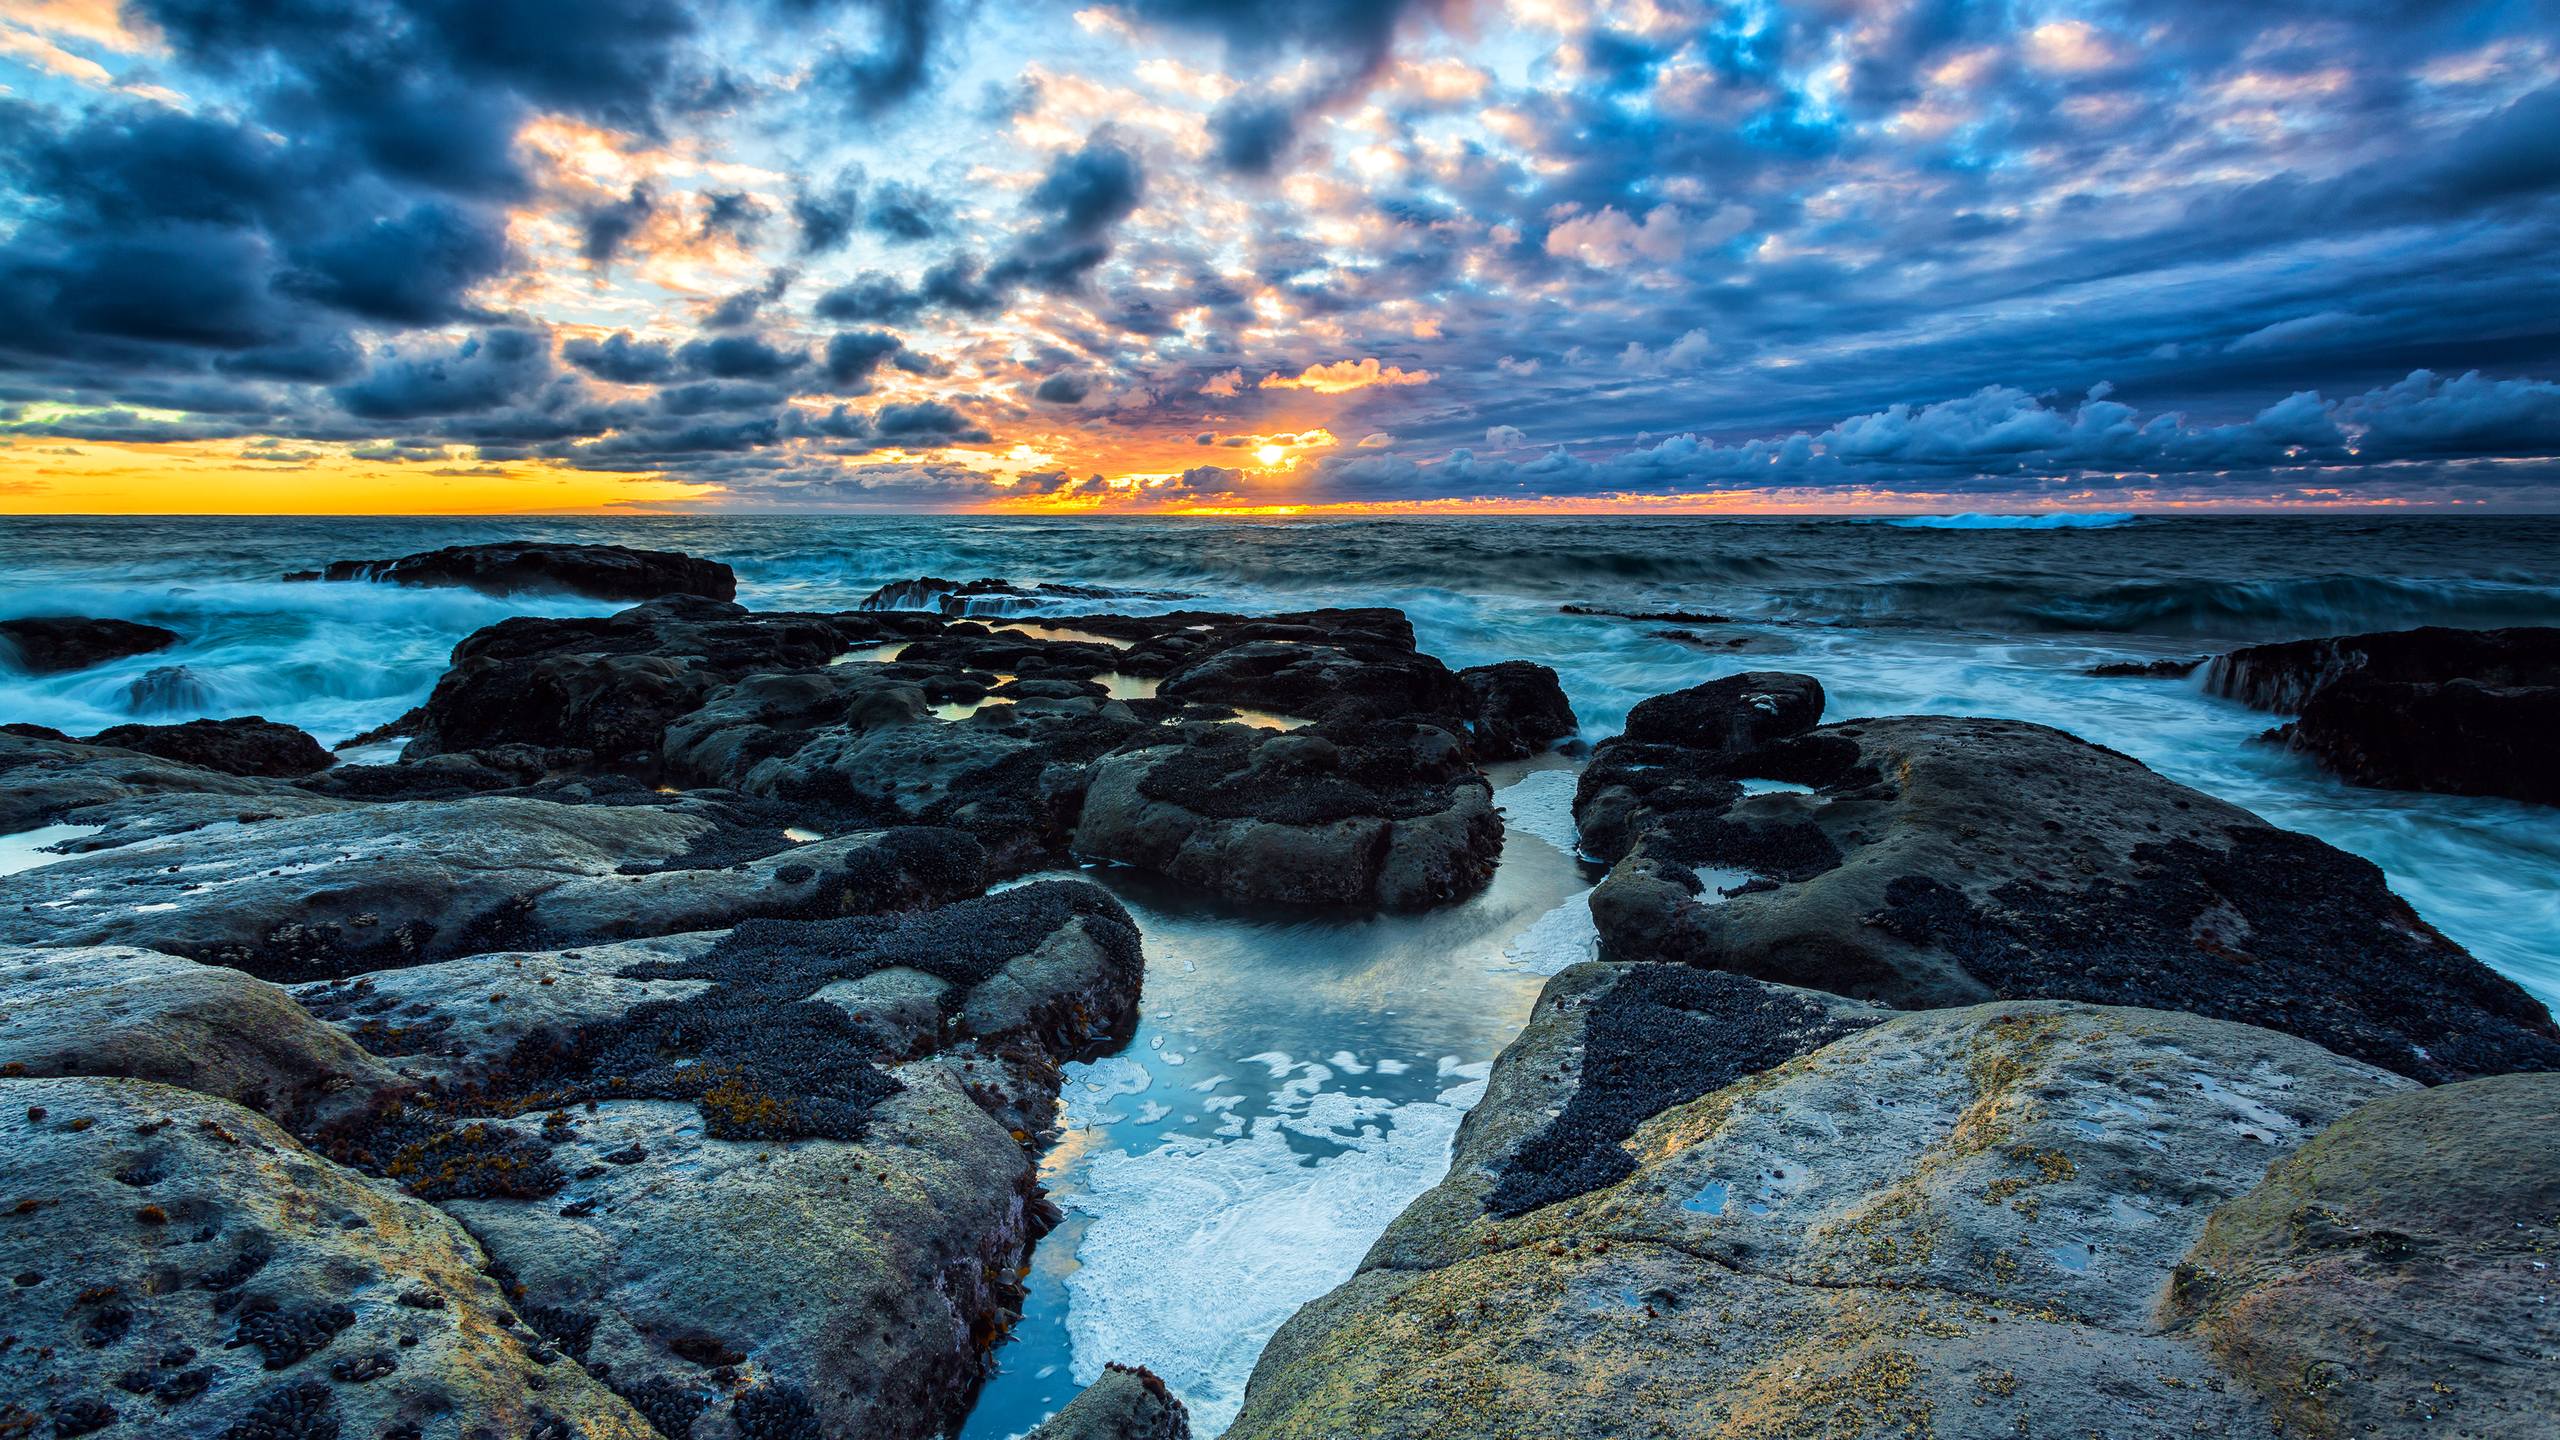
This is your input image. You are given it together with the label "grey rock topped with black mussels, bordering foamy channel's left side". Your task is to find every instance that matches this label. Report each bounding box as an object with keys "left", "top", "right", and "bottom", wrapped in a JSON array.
[{"left": 305, "top": 881, "right": 1144, "bottom": 1440}]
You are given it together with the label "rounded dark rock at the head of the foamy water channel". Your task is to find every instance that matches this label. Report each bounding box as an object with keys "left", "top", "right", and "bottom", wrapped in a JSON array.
[{"left": 1075, "top": 720, "right": 1503, "bottom": 910}]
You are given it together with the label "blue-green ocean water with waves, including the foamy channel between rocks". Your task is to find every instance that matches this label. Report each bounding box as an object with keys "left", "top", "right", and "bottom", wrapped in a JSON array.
[{"left": 0, "top": 515, "right": 2560, "bottom": 1440}]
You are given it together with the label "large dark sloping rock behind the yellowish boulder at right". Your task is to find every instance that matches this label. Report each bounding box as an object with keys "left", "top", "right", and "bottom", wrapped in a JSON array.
[{"left": 1574, "top": 682, "right": 2560, "bottom": 1084}]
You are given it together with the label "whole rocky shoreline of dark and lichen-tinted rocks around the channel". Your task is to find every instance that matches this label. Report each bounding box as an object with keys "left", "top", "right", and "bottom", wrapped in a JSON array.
[{"left": 0, "top": 546, "right": 2560, "bottom": 1440}]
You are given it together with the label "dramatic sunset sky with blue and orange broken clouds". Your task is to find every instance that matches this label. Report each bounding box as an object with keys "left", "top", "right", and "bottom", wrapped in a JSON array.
[{"left": 0, "top": 0, "right": 2560, "bottom": 512}]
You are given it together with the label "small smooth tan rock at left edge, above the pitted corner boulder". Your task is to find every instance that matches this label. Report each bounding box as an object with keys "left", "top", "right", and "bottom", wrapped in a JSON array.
[{"left": 0, "top": 945, "right": 404, "bottom": 1127}]
